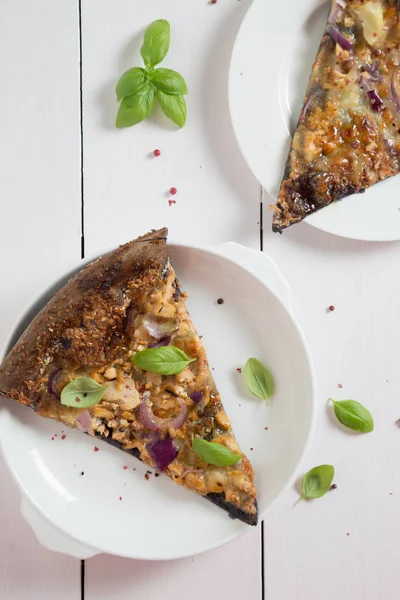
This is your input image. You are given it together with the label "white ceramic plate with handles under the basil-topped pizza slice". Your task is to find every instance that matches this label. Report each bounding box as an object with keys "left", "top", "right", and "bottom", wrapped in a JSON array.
[{"left": 0, "top": 244, "right": 315, "bottom": 560}]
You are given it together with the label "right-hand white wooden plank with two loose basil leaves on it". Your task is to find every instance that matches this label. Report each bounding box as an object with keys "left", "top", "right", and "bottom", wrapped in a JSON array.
[{"left": 264, "top": 192, "right": 400, "bottom": 600}]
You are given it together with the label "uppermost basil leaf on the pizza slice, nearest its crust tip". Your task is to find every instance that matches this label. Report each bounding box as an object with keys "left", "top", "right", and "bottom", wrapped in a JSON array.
[{"left": 131, "top": 346, "right": 197, "bottom": 375}]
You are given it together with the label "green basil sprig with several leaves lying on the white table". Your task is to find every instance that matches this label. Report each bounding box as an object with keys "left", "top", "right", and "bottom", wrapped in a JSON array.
[{"left": 115, "top": 19, "right": 188, "bottom": 128}]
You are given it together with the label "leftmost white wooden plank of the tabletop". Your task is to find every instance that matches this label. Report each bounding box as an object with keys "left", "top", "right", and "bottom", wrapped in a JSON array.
[{"left": 0, "top": 0, "right": 80, "bottom": 600}]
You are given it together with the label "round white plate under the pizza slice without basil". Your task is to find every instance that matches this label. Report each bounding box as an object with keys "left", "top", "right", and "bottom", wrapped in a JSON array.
[{"left": 229, "top": 0, "right": 400, "bottom": 241}]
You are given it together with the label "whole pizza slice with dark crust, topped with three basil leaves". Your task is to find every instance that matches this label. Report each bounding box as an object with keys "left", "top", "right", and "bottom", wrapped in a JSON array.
[{"left": 0, "top": 229, "right": 257, "bottom": 525}]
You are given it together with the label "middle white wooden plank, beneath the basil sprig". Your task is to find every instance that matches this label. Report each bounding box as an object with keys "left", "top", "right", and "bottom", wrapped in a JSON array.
[{"left": 82, "top": 0, "right": 261, "bottom": 600}]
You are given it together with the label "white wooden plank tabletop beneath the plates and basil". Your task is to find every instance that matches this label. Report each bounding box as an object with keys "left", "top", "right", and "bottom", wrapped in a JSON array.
[{"left": 0, "top": 0, "right": 400, "bottom": 600}]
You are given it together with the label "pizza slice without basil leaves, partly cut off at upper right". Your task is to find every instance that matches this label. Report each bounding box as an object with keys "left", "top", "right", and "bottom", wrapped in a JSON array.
[{"left": 272, "top": 0, "right": 400, "bottom": 232}]
